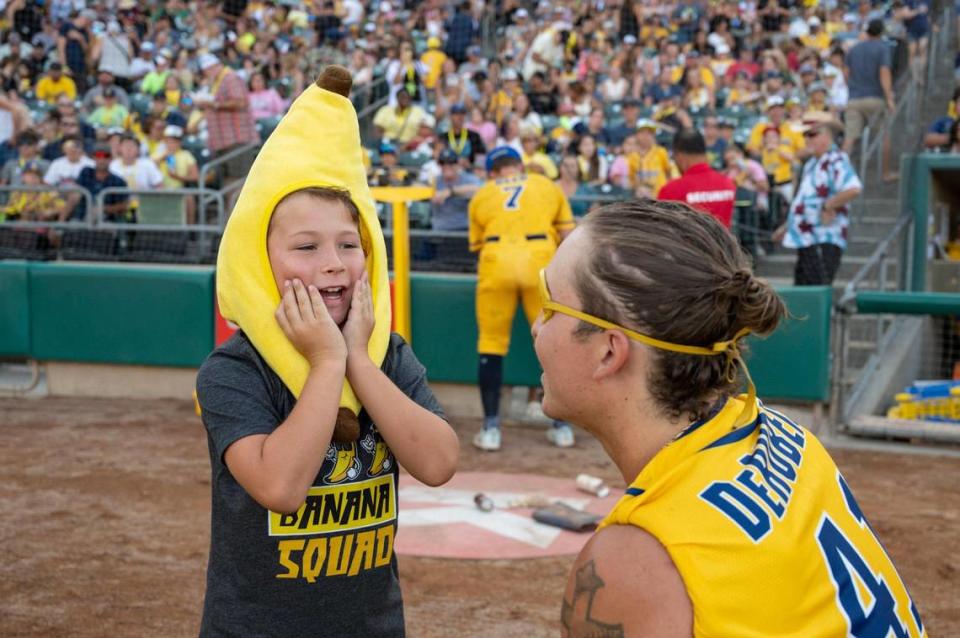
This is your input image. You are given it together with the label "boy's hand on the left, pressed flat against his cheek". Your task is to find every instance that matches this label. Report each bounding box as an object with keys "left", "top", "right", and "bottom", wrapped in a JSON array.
[{"left": 275, "top": 279, "right": 347, "bottom": 368}]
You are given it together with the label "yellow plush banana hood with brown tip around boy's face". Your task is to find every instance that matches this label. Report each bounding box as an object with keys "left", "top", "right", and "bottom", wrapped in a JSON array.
[{"left": 217, "top": 67, "right": 391, "bottom": 430}]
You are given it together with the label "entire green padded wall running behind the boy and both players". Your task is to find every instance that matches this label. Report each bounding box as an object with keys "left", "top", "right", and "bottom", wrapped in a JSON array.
[{"left": 9, "top": 262, "right": 832, "bottom": 401}]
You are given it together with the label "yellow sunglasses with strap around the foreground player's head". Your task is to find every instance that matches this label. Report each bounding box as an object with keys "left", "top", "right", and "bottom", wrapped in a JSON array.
[{"left": 540, "top": 268, "right": 757, "bottom": 427}]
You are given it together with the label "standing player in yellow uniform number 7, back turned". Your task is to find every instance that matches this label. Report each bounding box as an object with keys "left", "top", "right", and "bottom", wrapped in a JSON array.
[{"left": 469, "top": 146, "right": 574, "bottom": 451}]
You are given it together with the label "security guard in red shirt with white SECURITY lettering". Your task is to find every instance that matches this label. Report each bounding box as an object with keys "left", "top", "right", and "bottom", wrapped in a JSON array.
[{"left": 658, "top": 128, "right": 737, "bottom": 228}]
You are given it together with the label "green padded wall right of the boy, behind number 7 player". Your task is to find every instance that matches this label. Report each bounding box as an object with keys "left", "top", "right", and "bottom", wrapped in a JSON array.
[{"left": 411, "top": 273, "right": 832, "bottom": 401}]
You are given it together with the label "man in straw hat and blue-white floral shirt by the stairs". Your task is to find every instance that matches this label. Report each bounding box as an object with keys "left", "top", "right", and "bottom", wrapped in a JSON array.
[{"left": 774, "top": 111, "right": 863, "bottom": 286}]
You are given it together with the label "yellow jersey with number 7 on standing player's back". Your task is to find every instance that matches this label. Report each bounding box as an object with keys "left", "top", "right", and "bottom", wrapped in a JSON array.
[{"left": 468, "top": 173, "right": 574, "bottom": 251}]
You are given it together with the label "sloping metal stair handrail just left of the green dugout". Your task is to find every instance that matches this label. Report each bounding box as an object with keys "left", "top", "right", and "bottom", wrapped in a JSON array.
[{"left": 830, "top": 211, "right": 913, "bottom": 425}]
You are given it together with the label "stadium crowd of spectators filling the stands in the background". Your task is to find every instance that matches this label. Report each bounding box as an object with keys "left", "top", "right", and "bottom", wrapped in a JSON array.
[{"left": 0, "top": 0, "right": 944, "bottom": 247}]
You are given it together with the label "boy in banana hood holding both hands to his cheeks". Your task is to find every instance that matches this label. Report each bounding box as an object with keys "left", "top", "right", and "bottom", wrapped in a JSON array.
[{"left": 197, "top": 67, "right": 458, "bottom": 636}]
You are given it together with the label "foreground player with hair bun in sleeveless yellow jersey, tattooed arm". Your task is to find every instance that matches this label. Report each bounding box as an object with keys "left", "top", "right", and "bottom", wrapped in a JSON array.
[{"left": 533, "top": 200, "right": 926, "bottom": 638}]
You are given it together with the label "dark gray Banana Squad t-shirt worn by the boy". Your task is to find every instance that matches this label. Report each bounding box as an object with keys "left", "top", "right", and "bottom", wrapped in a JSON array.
[{"left": 197, "top": 332, "right": 443, "bottom": 638}]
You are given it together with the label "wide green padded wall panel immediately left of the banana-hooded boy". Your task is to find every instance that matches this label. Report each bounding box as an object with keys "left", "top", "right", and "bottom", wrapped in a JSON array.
[{"left": 30, "top": 263, "right": 214, "bottom": 366}]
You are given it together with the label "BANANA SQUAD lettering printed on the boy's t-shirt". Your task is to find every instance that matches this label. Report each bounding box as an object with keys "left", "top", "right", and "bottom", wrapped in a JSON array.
[{"left": 270, "top": 474, "right": 397, "bottom": 583}]
